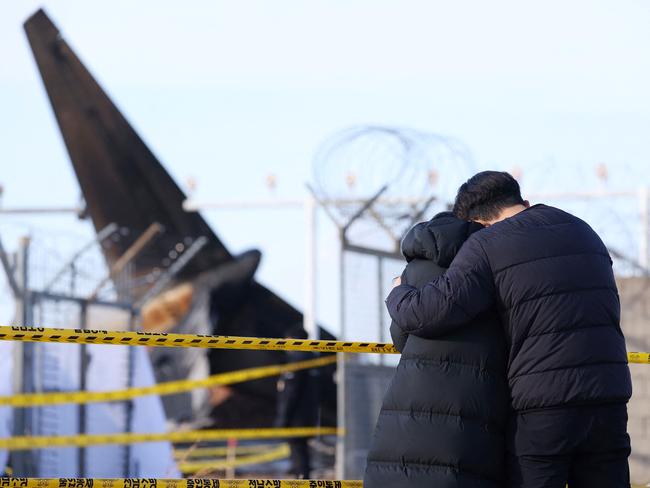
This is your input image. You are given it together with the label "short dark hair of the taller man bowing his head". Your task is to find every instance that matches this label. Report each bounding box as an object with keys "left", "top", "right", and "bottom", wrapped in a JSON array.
[{"left": 454, "top": 171, "right": 524, "bottom": 220}]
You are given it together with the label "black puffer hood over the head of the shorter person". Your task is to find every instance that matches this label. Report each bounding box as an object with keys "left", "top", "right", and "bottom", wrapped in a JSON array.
[{"left": 402, "top": 212, "right": 483, "bottom": 268}]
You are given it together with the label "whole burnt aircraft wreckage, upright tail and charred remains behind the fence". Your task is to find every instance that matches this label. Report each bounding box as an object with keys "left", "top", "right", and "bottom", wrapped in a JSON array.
[{"left": 24, "top": 10, "right": 336, "bottom": 427}]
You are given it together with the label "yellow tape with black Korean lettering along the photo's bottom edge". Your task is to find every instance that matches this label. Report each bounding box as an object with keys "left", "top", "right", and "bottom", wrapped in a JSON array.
[{"left": 0, "top": 478, "right": 363, "bottom": 488}]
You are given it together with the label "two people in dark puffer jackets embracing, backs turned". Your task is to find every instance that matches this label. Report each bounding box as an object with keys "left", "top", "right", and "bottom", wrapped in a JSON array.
[{"left": 364, "top": 171, "right": 632, "bottom": 488}]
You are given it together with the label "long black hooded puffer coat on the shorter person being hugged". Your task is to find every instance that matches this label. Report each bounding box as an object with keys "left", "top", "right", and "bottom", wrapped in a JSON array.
[{"left": 364, "top": 214, "right": 508, "bottom": 488}]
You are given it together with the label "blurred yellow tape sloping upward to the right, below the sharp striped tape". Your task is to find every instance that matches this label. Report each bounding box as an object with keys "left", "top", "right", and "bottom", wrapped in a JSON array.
[{"left": 0, "top": 356, "right": 336, "bottom": 407}]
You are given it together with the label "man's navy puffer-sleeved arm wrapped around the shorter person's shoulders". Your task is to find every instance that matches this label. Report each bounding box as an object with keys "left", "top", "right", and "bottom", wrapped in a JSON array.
[{"left": 386, "top": 235, "right": 495, "bottom": 338}]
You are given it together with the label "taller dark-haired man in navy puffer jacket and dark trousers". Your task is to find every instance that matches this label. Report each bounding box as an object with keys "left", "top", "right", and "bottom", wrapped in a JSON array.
[{"left": 386, "top": 171, "right": 632, "bottom": 488}]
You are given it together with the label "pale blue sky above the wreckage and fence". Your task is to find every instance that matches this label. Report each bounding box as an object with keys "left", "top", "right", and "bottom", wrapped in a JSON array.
[{"left": 0, "top": 0, "right": 650, "bottom": 334}]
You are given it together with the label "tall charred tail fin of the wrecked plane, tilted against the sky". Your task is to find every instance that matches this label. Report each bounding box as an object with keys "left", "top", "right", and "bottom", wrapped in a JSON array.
[{"left": 24, "top": 10, "right": 232, "bottom": 286}]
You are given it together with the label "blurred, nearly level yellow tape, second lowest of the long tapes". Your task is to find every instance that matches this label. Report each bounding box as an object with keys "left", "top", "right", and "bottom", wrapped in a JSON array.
[{"left": 0, "top": 427, "right": 342, "bottom": 450}]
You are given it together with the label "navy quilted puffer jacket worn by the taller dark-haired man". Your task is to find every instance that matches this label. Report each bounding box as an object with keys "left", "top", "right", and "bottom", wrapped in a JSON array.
[{"left": 386, "top": 205, "right": 632, "bottom": 411}]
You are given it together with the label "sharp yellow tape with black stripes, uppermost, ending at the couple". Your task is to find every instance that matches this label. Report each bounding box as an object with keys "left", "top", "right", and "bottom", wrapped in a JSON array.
[{"left": 0, "top": 326, "right": 399, "bottom": 352}]
